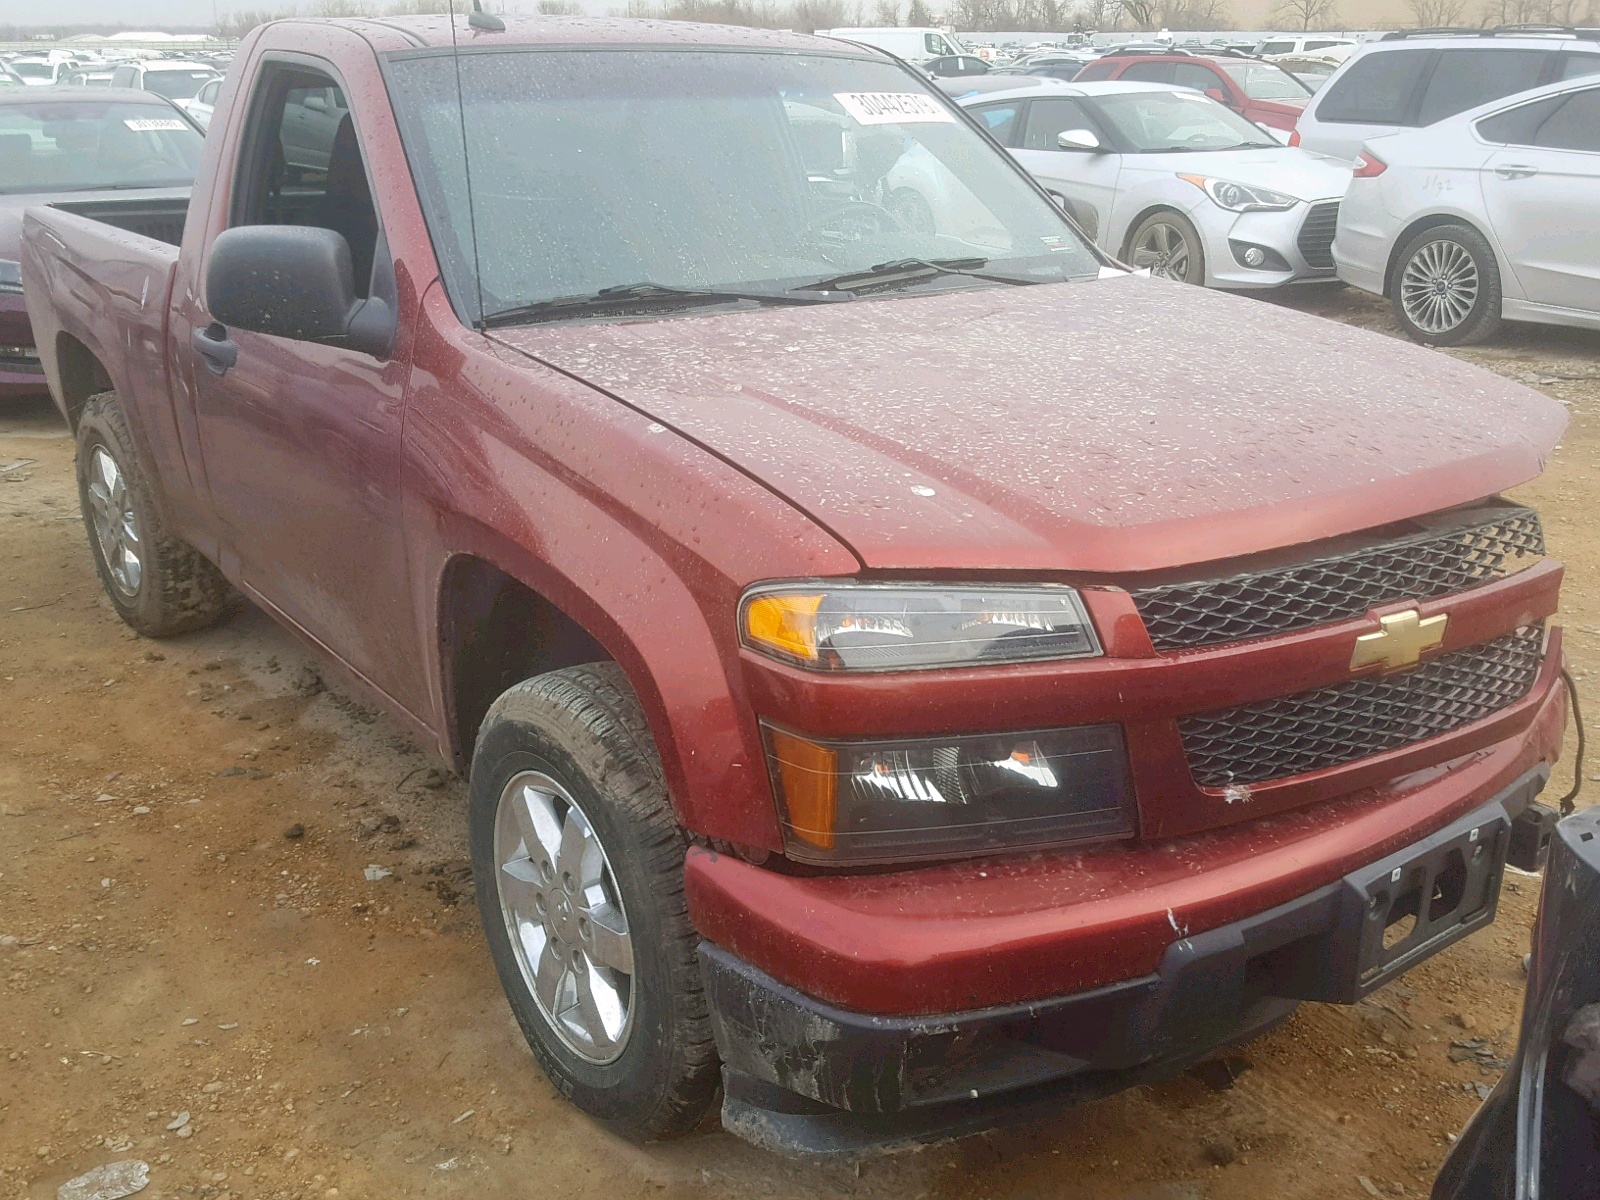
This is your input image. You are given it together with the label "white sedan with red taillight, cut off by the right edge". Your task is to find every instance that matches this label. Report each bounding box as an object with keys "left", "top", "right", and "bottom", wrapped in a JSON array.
[{"left": 1333, "top": 77, "right": 1600, "bottom": 346}]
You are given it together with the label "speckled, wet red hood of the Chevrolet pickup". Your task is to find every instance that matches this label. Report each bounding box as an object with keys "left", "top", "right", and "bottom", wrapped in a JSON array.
[{"left": 493, "top": 274, "right": 1566, "bottom": 573}]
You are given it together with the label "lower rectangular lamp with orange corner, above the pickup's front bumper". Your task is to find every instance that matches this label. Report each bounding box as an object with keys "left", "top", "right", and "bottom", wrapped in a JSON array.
[{"left": 762, "top": 723, "right": 1133, "bottom": 862}]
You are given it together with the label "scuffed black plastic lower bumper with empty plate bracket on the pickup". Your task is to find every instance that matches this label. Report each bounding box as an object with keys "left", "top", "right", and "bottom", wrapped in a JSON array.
[{"left": 701, "top": 766, "right": 1547, "bottom": 1157}]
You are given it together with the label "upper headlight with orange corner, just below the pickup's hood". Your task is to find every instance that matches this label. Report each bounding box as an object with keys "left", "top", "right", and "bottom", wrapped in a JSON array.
[{"left": 739, "top": 582, "right": 1101, "bottom": 670}]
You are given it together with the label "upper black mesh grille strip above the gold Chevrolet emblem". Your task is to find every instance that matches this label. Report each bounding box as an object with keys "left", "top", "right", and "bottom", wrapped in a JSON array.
[{"left": 1133, "top": 506, "right": 1544, "bottom": 650}]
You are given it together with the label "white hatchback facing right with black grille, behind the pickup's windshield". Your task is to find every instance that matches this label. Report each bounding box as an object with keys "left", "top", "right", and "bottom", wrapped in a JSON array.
[{"left": 960, "top": 82, "right": 1350, "bottom": 288}]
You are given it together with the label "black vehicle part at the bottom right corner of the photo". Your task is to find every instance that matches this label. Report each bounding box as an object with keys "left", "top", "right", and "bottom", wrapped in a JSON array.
[{"left": 1434, "top": 808, "right": 1600, "bottom": 1200}]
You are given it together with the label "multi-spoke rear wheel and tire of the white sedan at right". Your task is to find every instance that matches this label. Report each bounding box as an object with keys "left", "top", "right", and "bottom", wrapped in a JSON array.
[{"left": 1389, "top": 224, "right": 1501, "bottom": 346}]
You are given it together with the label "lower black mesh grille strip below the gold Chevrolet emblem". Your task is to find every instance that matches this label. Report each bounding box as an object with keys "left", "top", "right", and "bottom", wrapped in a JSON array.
[{"left": 1178, "top": 626, "right": 1544, "bottom": 787}]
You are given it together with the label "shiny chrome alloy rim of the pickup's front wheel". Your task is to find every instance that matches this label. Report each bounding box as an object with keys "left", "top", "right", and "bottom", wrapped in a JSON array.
[{"left": 494, "top": 771, "right": 634, "bottom": 1066}]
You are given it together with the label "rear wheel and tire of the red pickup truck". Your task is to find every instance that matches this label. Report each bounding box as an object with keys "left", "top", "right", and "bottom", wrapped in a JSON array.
[{"left": 77, "top": 392, "right": 232, "bottom": 637}]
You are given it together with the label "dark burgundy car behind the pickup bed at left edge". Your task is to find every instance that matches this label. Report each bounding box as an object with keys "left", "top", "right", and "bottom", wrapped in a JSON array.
[{"left": 0, "top": 88, "right": 202, "bottom": 400}]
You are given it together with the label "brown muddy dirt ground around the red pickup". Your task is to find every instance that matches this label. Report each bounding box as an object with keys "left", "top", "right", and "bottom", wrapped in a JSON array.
[{"left": 0, "top": 291, "right": 1600, "bottom": 1200}]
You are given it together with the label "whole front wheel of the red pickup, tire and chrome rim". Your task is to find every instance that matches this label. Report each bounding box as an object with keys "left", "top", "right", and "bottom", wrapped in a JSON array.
[{"left": 469, "top": 662, "right": 718, "bottom": 1141}]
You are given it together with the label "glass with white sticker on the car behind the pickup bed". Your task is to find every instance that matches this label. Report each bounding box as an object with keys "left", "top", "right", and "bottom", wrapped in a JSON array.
[{"left": 0, "top": 101, "right": 202, "bottom": 195}]
